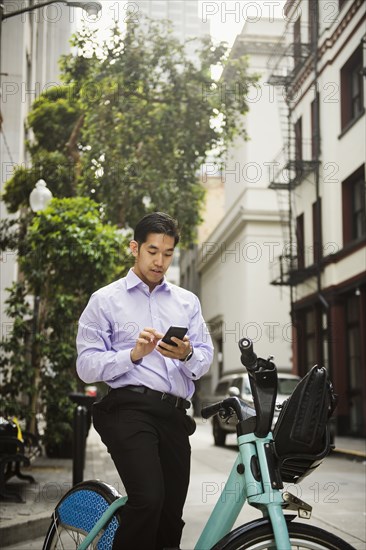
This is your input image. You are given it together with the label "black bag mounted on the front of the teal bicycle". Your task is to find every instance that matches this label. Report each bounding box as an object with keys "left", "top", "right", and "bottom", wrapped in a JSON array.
[{"left": 273, "top": 365, "right": 337, "bottom": 483}]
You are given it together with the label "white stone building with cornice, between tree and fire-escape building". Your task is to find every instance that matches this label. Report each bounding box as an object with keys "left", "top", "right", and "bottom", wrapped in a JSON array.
[{"left": 193, "top": 18, "right": 292, "bottom": 402}]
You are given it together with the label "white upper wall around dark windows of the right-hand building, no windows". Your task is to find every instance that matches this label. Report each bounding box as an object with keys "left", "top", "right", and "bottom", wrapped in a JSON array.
[{"left": 292, "top": 1, "right": 366, "bottom": 299}]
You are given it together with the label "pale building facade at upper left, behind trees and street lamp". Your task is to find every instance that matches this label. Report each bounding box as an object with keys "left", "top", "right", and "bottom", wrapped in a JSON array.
[{"left": 0, "top": 0, "right": 77, "bottom": 328}]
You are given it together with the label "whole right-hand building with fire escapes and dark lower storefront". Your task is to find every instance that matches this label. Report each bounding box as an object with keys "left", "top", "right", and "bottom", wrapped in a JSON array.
[{"left": 269, "top": 0, "right": 366, "bottom": 436}]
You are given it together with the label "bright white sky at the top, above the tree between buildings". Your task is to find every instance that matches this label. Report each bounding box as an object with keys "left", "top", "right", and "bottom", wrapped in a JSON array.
[{"left": 77, "top": 0, "right": 284, "bottom": 46}]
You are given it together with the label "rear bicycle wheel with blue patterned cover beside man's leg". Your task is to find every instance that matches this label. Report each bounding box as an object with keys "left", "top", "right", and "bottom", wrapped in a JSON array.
[{"left": 43, "top": 481, "right": 121, "bottom": 550}]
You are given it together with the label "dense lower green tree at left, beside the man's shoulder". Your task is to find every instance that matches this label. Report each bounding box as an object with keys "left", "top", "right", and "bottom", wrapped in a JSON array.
[{"left": 0, "top": 198, "right": 129, "bottom": 454}]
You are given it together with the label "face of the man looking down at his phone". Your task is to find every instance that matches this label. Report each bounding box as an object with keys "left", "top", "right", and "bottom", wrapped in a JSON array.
[{"left": 130, "top": 233, "right": 174, "bottom": 291}]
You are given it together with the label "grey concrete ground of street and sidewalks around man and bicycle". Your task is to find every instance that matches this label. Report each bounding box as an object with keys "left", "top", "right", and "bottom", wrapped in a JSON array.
[{"left": 0, "top": 419, "right": 366, "bottom": 550}]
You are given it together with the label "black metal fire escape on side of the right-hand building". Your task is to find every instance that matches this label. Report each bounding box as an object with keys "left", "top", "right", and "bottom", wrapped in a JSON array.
[{"left": 268, "top": 8, "right": 319, "bottom": 287}]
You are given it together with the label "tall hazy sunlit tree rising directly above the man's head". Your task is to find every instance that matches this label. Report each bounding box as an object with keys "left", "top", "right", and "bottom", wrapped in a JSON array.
[{"left": 64, "top": 20, "right": 256, "bottom": 243}]
